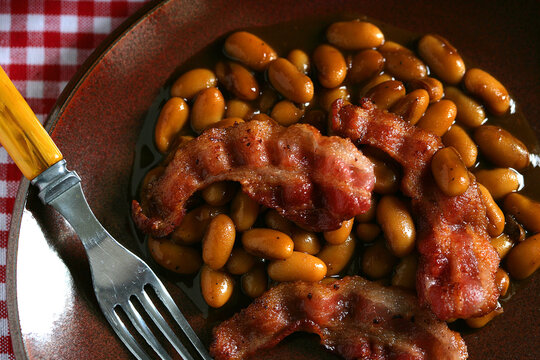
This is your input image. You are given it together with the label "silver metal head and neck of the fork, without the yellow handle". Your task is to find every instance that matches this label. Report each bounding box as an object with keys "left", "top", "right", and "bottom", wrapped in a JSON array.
[{"left": 32, "top": 160, "right": 211, "bottom": 360}]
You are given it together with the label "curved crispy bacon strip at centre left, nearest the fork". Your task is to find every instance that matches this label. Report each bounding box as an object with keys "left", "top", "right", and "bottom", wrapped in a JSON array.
[{"left": 132, "top": 121, "right": 375, "bottom": 237}]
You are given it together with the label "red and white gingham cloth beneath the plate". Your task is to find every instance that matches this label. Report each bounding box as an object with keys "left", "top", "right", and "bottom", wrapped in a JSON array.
[{"left": 0, "top": 0, "right": 145, "bottom": 360}]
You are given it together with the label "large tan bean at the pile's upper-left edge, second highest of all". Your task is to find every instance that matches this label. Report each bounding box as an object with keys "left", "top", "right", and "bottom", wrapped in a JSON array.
[{"left": 224, "top": 31, "right": 277, "bottom": 71}]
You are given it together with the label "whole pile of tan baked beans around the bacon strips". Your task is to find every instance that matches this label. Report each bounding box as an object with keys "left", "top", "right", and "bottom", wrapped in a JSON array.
[{"left": 144, "top": 21, "right": 540, "bottom": 327}]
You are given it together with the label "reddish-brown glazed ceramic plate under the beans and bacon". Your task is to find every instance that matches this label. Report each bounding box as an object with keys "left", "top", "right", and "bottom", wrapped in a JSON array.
[{"left": 8, "top": 0, "right": 540, "bottom": 360}]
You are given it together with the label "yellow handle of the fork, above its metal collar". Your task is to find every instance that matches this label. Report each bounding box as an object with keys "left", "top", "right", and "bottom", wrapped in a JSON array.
[{"left": 0, "top": 67, "right": 63, "bottom": 180}]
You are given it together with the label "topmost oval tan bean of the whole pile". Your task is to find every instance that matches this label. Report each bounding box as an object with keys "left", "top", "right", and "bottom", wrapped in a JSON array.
[{"left": 326, "top": 20, "right": 384, "bottom": 50}]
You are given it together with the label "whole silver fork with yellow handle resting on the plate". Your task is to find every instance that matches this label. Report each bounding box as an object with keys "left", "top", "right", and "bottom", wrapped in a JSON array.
[{"left": 0, "top": 67, "right": 211, "bottom": 360}]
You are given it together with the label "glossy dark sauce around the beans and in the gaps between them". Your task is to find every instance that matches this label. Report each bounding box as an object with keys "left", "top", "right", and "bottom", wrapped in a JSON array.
[{"left": 130, "top": 15, "right": 540, "bottom": 326}]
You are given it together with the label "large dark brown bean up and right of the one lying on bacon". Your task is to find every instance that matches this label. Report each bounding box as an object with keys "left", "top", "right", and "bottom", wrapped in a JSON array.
[{"left": 474, "top": 125, "right": 529, "bottom": 170}]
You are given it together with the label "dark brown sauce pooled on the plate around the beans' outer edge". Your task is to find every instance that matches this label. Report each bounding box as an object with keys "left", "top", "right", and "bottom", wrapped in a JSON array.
[{"left": 130, "top": 15, "right": 540, "bottom": 324}]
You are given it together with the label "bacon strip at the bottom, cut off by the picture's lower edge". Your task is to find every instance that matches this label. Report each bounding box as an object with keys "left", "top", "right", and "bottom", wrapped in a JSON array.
[{"left": 210, "top": 276, "right": 467, "bottom": 360}]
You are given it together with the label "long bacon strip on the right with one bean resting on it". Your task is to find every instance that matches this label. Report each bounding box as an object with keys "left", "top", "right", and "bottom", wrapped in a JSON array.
[{"left": 332, "top": 100, "right": 500, "bottom": 320}]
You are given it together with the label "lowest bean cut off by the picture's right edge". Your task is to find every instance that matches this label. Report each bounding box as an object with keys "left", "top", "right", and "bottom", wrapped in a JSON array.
[{"left": 506, "top": 234, "right": 540, "bottom": 280}]
